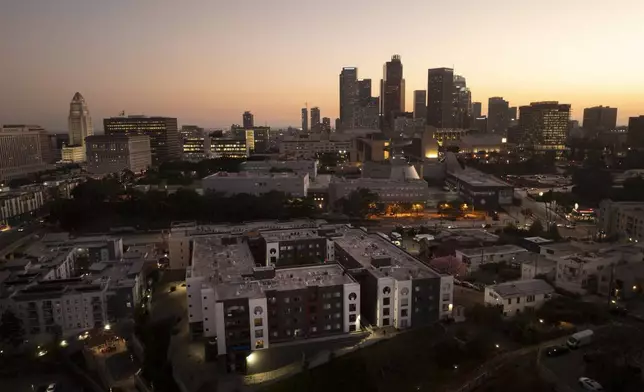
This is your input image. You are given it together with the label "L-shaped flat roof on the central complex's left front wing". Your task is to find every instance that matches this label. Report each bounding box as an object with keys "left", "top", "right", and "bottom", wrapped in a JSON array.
[{"left": 192, "top": 236, "right": 355, "bottom": 300}]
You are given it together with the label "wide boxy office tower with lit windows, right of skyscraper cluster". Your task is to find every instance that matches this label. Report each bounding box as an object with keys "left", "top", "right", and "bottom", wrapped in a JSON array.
[{"left": 516, "top": 101, "right": 570, "bottom": 152}]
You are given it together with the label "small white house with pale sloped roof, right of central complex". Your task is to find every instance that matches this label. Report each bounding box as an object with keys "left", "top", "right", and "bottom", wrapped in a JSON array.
[{"left": 484, "top": 279, "right": 555, "bottom": 317}]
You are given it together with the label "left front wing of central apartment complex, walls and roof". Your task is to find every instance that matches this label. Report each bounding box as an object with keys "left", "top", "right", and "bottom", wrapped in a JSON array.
[{"left": 186, "top": 236, "right": 360, "bottom": 362}]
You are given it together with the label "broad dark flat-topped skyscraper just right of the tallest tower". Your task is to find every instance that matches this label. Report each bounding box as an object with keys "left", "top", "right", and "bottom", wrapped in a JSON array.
[{"left": 427, "top": 68, "right": 454, "bottom": 128}]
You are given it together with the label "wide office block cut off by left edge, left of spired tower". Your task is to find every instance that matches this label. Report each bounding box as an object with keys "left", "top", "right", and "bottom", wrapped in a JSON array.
[{"left": 0, "top": 124, "right": 53, "bottom": 181}]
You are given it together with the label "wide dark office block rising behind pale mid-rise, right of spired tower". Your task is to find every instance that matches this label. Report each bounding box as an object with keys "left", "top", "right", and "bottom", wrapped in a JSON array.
[{"left": 103, "top": 115, "right": 181, "bottom": 166}]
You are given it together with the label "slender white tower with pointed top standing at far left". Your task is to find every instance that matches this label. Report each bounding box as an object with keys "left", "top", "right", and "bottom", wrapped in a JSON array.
[{"left": 62, "top": 92, "right": 94, "bottom": 162}]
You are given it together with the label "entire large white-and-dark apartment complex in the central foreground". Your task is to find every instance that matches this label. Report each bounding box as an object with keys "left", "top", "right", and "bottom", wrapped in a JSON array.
[{"left": 181, "top": 221, "right": 453, "bottom": 358}]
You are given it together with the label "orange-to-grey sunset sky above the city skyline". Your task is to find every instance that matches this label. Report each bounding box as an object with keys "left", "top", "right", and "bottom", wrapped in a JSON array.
[{"left": 0, "top": 0, "right": 644, "bottom": 131}]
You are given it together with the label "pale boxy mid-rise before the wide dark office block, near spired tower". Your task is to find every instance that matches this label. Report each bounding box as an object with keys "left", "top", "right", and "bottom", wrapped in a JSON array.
[{"left": 85, "top": 134, "right": 152, "bottom": 174}]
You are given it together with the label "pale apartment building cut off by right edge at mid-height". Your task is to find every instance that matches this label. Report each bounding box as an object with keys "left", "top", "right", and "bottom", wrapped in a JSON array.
[{"left": 597, "top": 199, "right": 644, "bottom": 241}]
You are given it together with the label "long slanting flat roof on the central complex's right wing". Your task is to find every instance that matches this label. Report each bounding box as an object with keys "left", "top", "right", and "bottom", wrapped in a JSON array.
[{"left": 334, "top": 227, "right": 441, "bottom": 280}]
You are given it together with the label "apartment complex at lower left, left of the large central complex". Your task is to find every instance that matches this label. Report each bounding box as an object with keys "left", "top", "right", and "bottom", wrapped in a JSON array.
[{"left": 0, "top": 233, "right": 157, "bottom": 342}]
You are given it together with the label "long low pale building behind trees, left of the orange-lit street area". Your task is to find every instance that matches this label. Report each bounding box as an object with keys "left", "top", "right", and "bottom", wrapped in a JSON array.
[{"left": 201, "top": 172, "right": 309, "bottom": 197}]
